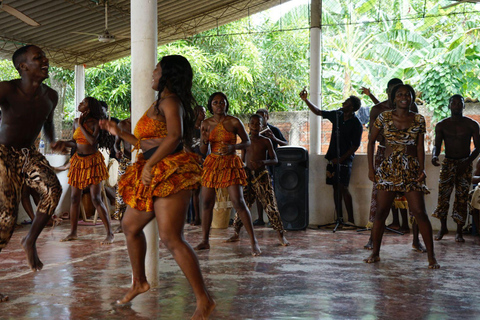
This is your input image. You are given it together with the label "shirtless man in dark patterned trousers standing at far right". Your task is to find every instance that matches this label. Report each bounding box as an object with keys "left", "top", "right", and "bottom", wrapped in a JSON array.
[{"left": 432, "top": 94, "right": 480, "bottom": 242}]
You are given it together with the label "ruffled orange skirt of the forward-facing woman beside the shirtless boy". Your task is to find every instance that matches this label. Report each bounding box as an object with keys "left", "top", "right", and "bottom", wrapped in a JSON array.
[{"left": 202, "top": 154, "right": 247, "bottom": 189}]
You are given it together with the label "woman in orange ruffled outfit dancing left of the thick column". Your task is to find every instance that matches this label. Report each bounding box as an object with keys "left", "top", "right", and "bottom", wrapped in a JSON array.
[{"left": 58, "top": 97, "right": 113, "bottom": 244}]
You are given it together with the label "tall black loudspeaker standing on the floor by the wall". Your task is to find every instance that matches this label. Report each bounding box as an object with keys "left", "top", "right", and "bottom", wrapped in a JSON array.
[{"left": 274, "top": 147, "right": 308, "bottom": 230}]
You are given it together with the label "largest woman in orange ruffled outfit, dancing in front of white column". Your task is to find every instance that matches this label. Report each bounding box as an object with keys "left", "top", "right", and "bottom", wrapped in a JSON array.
[{"left": 101, "top": 55, "right": 215, "bottom": 319}]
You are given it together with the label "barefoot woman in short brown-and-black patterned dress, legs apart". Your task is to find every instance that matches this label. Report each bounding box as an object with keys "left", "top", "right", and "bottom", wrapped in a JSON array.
[{"left": 364, "top": 84, "right": 440, "bottom": 269}]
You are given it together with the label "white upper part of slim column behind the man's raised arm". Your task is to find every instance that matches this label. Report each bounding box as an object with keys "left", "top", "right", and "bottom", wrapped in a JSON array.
[{"left": 309, "top": 0, "right": 322, "bottom": 155}]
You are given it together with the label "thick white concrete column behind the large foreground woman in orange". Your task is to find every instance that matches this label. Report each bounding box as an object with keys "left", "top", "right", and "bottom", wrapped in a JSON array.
[{"left": 130, "top": 0, "right": 159, "bottom": 287}]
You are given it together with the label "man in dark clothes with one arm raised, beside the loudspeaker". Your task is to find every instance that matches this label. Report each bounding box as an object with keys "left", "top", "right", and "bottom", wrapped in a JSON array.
[{"left": 300, "top": 90, "right": 363, "bottom": 224}]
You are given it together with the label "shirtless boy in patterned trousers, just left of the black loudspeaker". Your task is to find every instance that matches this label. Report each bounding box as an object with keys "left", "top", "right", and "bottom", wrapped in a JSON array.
[{"left": 227, "top": 113, "right": 290, "bottom": 246}]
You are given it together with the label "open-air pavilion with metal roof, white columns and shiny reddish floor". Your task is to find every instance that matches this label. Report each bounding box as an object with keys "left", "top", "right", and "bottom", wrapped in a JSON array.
[{"left": 0, "top": 0, "right": 480, "bottom": 319}]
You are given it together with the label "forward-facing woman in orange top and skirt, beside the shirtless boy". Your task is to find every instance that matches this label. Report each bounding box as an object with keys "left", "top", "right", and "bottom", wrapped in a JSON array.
[{"left": 195, "top": 92, "right": 261, "bottom": 256}]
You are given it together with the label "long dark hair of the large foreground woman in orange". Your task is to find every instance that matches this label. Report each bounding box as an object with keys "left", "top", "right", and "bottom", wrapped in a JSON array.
[{"left": 155, "top": 55, "right": 197, "bottom": 147}]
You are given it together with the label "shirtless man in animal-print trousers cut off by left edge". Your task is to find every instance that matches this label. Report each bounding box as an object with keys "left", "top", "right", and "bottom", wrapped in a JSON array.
[{"left": 0, "top": 45, "right": 62, "bottom": 300}]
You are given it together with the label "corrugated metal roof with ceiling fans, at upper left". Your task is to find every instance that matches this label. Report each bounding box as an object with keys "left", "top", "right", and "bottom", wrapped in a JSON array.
[{"left": 0, "top": 0, "right": 290, "bottom": 69}]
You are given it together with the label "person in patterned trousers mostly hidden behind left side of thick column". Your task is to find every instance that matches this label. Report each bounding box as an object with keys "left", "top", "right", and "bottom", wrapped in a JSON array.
[{"left": 113, "top": 118, "right": 132, "bottom": 233}]
